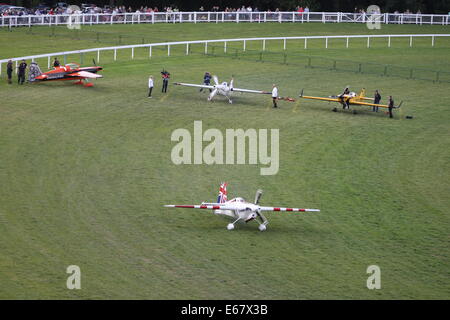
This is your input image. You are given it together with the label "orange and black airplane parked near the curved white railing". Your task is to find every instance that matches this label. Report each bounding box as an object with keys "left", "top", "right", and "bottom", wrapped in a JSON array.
[{"left": 28, "top": 62, "right": 103, "bottom": 87}]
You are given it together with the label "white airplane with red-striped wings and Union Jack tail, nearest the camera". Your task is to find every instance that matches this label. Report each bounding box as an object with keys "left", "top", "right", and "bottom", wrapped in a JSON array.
[{"left": 165, "top": 183, "right": 320, "bottom": 231}]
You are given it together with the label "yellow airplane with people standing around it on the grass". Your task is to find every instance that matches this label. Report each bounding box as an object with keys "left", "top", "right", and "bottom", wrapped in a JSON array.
[{"left": 299, "top": 87, "right": 403, "bottom": 113}]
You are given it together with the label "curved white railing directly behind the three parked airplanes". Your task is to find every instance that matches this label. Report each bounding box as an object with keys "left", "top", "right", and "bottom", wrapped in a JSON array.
[{"left": 0, "top": 34, "right": 450, "bottom": 76}]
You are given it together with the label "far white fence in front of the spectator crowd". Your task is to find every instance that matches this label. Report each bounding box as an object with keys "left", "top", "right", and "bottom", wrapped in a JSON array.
[{"left": 0, "top": 11, "right": 450, "bottom": 27}]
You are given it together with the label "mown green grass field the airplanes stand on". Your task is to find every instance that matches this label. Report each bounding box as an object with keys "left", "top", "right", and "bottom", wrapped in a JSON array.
[{"left": 0, "top": 24, "right": 450, "bottom": 299}]
